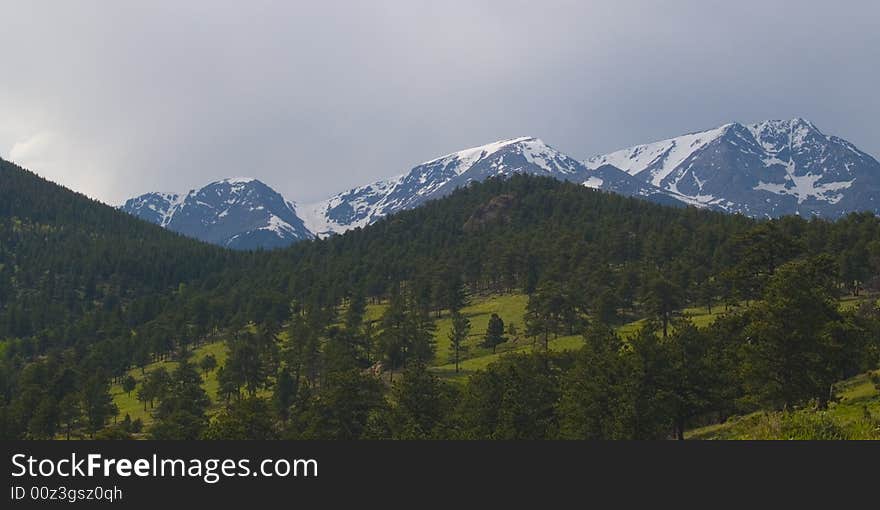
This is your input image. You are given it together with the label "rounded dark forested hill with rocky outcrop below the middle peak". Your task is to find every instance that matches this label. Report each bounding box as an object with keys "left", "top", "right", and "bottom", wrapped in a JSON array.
[{"left": 258, "top": 175, "right": 756, "bottom": 304}]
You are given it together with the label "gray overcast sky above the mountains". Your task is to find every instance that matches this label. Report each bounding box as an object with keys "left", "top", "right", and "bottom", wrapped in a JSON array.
[{"left": 0, "top": 0, "right": 880, "bottom": 203}]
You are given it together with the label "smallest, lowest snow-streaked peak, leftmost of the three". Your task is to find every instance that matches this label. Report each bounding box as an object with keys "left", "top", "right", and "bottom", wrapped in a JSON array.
[{"left": 120, "top": 178, "right": 313, "bottom": 250}]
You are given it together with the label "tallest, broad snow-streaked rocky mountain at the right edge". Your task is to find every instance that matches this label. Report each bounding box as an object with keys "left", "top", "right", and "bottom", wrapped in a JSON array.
[{"left": 585, "top": 118, "right": 880, "bottom": 218}]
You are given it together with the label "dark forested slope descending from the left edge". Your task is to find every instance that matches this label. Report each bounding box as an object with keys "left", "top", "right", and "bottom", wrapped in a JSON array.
[{"left": 0, "top": 160, "right": 240, "bottom": 355}]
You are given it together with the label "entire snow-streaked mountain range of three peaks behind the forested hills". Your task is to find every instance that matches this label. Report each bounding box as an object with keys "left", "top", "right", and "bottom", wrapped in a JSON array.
[{"left": 121, "top": 118, "right": 880, "bottom": 249}]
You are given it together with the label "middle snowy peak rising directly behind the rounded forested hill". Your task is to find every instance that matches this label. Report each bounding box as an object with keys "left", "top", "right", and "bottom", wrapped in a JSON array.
[{"left": 300, "top": 133, "right": 680, "bottom": 235}]
